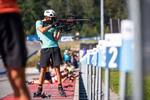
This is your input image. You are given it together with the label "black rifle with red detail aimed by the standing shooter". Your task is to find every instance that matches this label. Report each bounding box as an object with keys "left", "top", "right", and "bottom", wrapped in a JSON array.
[{"left": 42, "top": 15, "right": 90, "bottom": 32}]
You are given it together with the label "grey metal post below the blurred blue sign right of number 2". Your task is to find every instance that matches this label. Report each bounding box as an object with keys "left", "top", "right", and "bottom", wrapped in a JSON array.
[{"left": 119, "top": 72, "right": 126, "bottom": 100}]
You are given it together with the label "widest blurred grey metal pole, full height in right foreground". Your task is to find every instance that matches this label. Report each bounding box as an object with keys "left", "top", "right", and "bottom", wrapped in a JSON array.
[{"left": 128, "top": 0, "right": 143, "bottom": 100}]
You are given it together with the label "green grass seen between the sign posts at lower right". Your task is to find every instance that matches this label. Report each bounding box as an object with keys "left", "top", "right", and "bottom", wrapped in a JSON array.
[{"left": 102, "top": 69, "right": 150, "bottom": 100}]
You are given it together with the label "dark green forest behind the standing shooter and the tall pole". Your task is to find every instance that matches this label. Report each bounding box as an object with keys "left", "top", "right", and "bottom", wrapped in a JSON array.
[{"left": 18, "top": 0, "right": 127, "bottom": 37}]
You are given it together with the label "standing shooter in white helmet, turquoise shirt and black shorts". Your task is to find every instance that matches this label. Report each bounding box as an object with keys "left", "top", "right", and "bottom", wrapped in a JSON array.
[{"left": 36, "top": 9, "right": 66, "bottom": 96}]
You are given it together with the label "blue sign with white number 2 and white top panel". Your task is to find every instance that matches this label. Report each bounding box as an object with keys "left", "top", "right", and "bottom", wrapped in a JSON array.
[{"left": 105, "top": 34, "right": 122, "bottom": 69}]
